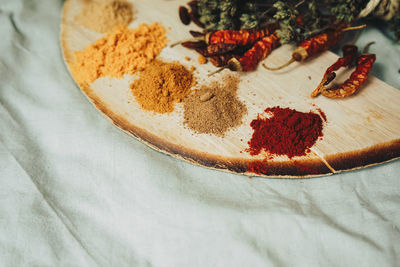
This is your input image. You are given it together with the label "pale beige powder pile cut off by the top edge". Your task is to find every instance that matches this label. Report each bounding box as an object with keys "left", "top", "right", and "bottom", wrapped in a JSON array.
[{"left": 75, "top": 0, "right": 135, "bottom": 33}]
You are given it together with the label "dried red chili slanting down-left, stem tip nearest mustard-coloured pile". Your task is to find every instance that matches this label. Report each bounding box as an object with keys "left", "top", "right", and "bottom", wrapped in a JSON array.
[{"left": 209, "top": 33, "right": 280, "bottom": 76}]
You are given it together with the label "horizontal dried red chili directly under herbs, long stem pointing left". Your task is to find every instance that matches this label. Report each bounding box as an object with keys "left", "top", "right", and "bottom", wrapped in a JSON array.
[{"left": 171, "top": 23, "right": 279, "bottom": 47}]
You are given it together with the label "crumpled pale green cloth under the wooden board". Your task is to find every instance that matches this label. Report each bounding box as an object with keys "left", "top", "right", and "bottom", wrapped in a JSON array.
[{"left": 0, "top": 0, "right": 400, "bottom": 266}]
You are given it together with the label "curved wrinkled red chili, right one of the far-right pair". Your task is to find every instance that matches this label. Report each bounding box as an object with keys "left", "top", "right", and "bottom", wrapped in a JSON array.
[{"left": 321, "top": 43, "right": 376, "bottom": 98}]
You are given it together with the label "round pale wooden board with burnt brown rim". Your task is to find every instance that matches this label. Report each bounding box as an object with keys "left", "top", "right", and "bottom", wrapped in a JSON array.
[{"left": 60, "top": 0, "right": 400, "bottom": 178}]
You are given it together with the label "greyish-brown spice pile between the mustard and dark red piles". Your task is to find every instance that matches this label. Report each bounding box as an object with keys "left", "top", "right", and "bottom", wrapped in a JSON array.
[{"left": 184, "top": 75, "right": 247, "bottom": 136}]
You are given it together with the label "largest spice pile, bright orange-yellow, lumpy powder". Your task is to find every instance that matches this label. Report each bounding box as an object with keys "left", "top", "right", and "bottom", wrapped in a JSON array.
[{"left": 71, "top": 23, "right": 167, "bottom": 85}]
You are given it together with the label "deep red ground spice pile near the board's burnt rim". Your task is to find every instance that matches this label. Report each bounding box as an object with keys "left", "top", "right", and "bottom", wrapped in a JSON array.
[{"left": 248, "top": 106, "right": 323, "bottom": 158}]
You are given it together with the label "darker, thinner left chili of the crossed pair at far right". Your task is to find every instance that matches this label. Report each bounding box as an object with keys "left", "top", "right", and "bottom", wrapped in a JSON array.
[{"left": 311, "top": 44, "right": 358, "bottom": 97}]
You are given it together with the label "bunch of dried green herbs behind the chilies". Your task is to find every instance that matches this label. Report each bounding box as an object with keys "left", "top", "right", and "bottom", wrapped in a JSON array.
[{"left": 190, "top": 0, "right": 400, "bottom": 43}]
